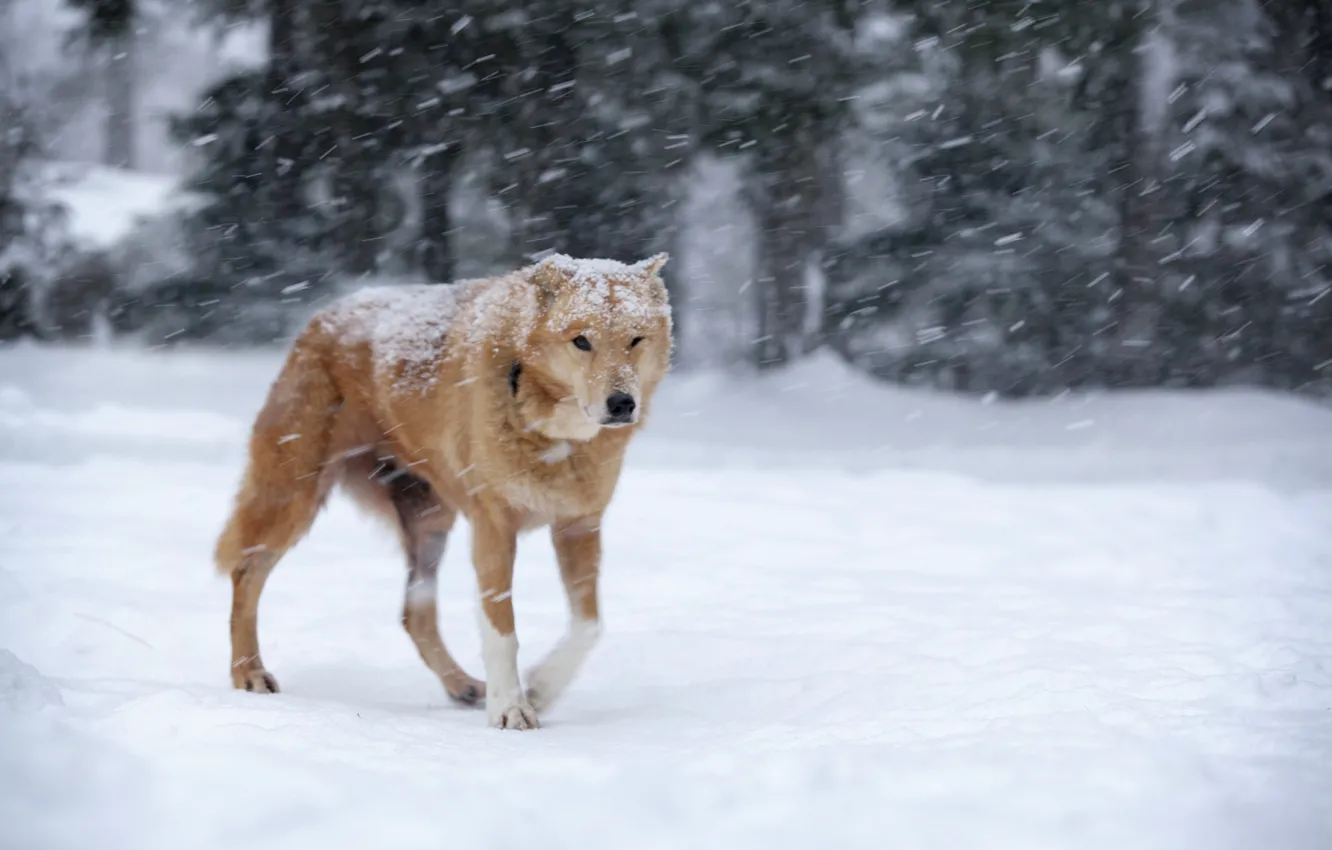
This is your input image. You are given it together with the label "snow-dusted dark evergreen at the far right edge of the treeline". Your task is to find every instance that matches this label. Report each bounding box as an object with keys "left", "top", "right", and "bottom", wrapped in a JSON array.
[{"left": 1167, "top": 0, "right": 1332, "bottom": 388}]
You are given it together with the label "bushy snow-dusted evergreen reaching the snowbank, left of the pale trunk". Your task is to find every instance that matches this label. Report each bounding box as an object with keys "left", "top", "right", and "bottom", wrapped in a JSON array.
[{"left": 825, "top": 4, "right": 1116, "bottom": 394}]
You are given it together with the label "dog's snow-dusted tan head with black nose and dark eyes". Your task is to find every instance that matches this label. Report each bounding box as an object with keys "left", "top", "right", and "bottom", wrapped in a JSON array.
[{"left": 521, "top": 253, "right": 671, "bottom": 440}]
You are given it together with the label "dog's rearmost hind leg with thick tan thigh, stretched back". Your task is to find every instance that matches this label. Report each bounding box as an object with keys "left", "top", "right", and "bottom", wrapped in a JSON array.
[{"left": 214, "top": 342, "right": 340, "bottom": 693}]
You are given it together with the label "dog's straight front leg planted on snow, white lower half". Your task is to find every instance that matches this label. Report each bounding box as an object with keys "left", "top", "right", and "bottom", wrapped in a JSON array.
[{"left": 472, "top": 516, "right": 538, "bottom": 729}]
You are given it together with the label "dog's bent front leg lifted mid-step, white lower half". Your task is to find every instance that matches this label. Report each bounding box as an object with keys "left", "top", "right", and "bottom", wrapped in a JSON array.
[{"left": 527, "top": 517, "right": 601, "bottom": 711}]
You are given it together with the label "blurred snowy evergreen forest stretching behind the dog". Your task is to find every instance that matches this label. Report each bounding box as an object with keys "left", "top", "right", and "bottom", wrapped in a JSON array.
[{"left": 0, "top": 0, "right": 1332, "bottom": 396}]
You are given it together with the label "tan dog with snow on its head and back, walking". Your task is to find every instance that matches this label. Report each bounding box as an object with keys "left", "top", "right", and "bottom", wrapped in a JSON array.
[{"left": 214, "top": 253, "right": 671, "bottom": 729}]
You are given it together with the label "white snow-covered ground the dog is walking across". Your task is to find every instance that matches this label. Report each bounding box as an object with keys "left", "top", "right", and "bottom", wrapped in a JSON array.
[{"left": 0, "top": 348, "right": 1332, "bottom": 850}]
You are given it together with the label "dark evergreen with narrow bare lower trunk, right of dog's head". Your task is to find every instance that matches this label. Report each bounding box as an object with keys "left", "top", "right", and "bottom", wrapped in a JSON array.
[{"left": 650, "top": 0, "right": 883, "bottom": 368}]
